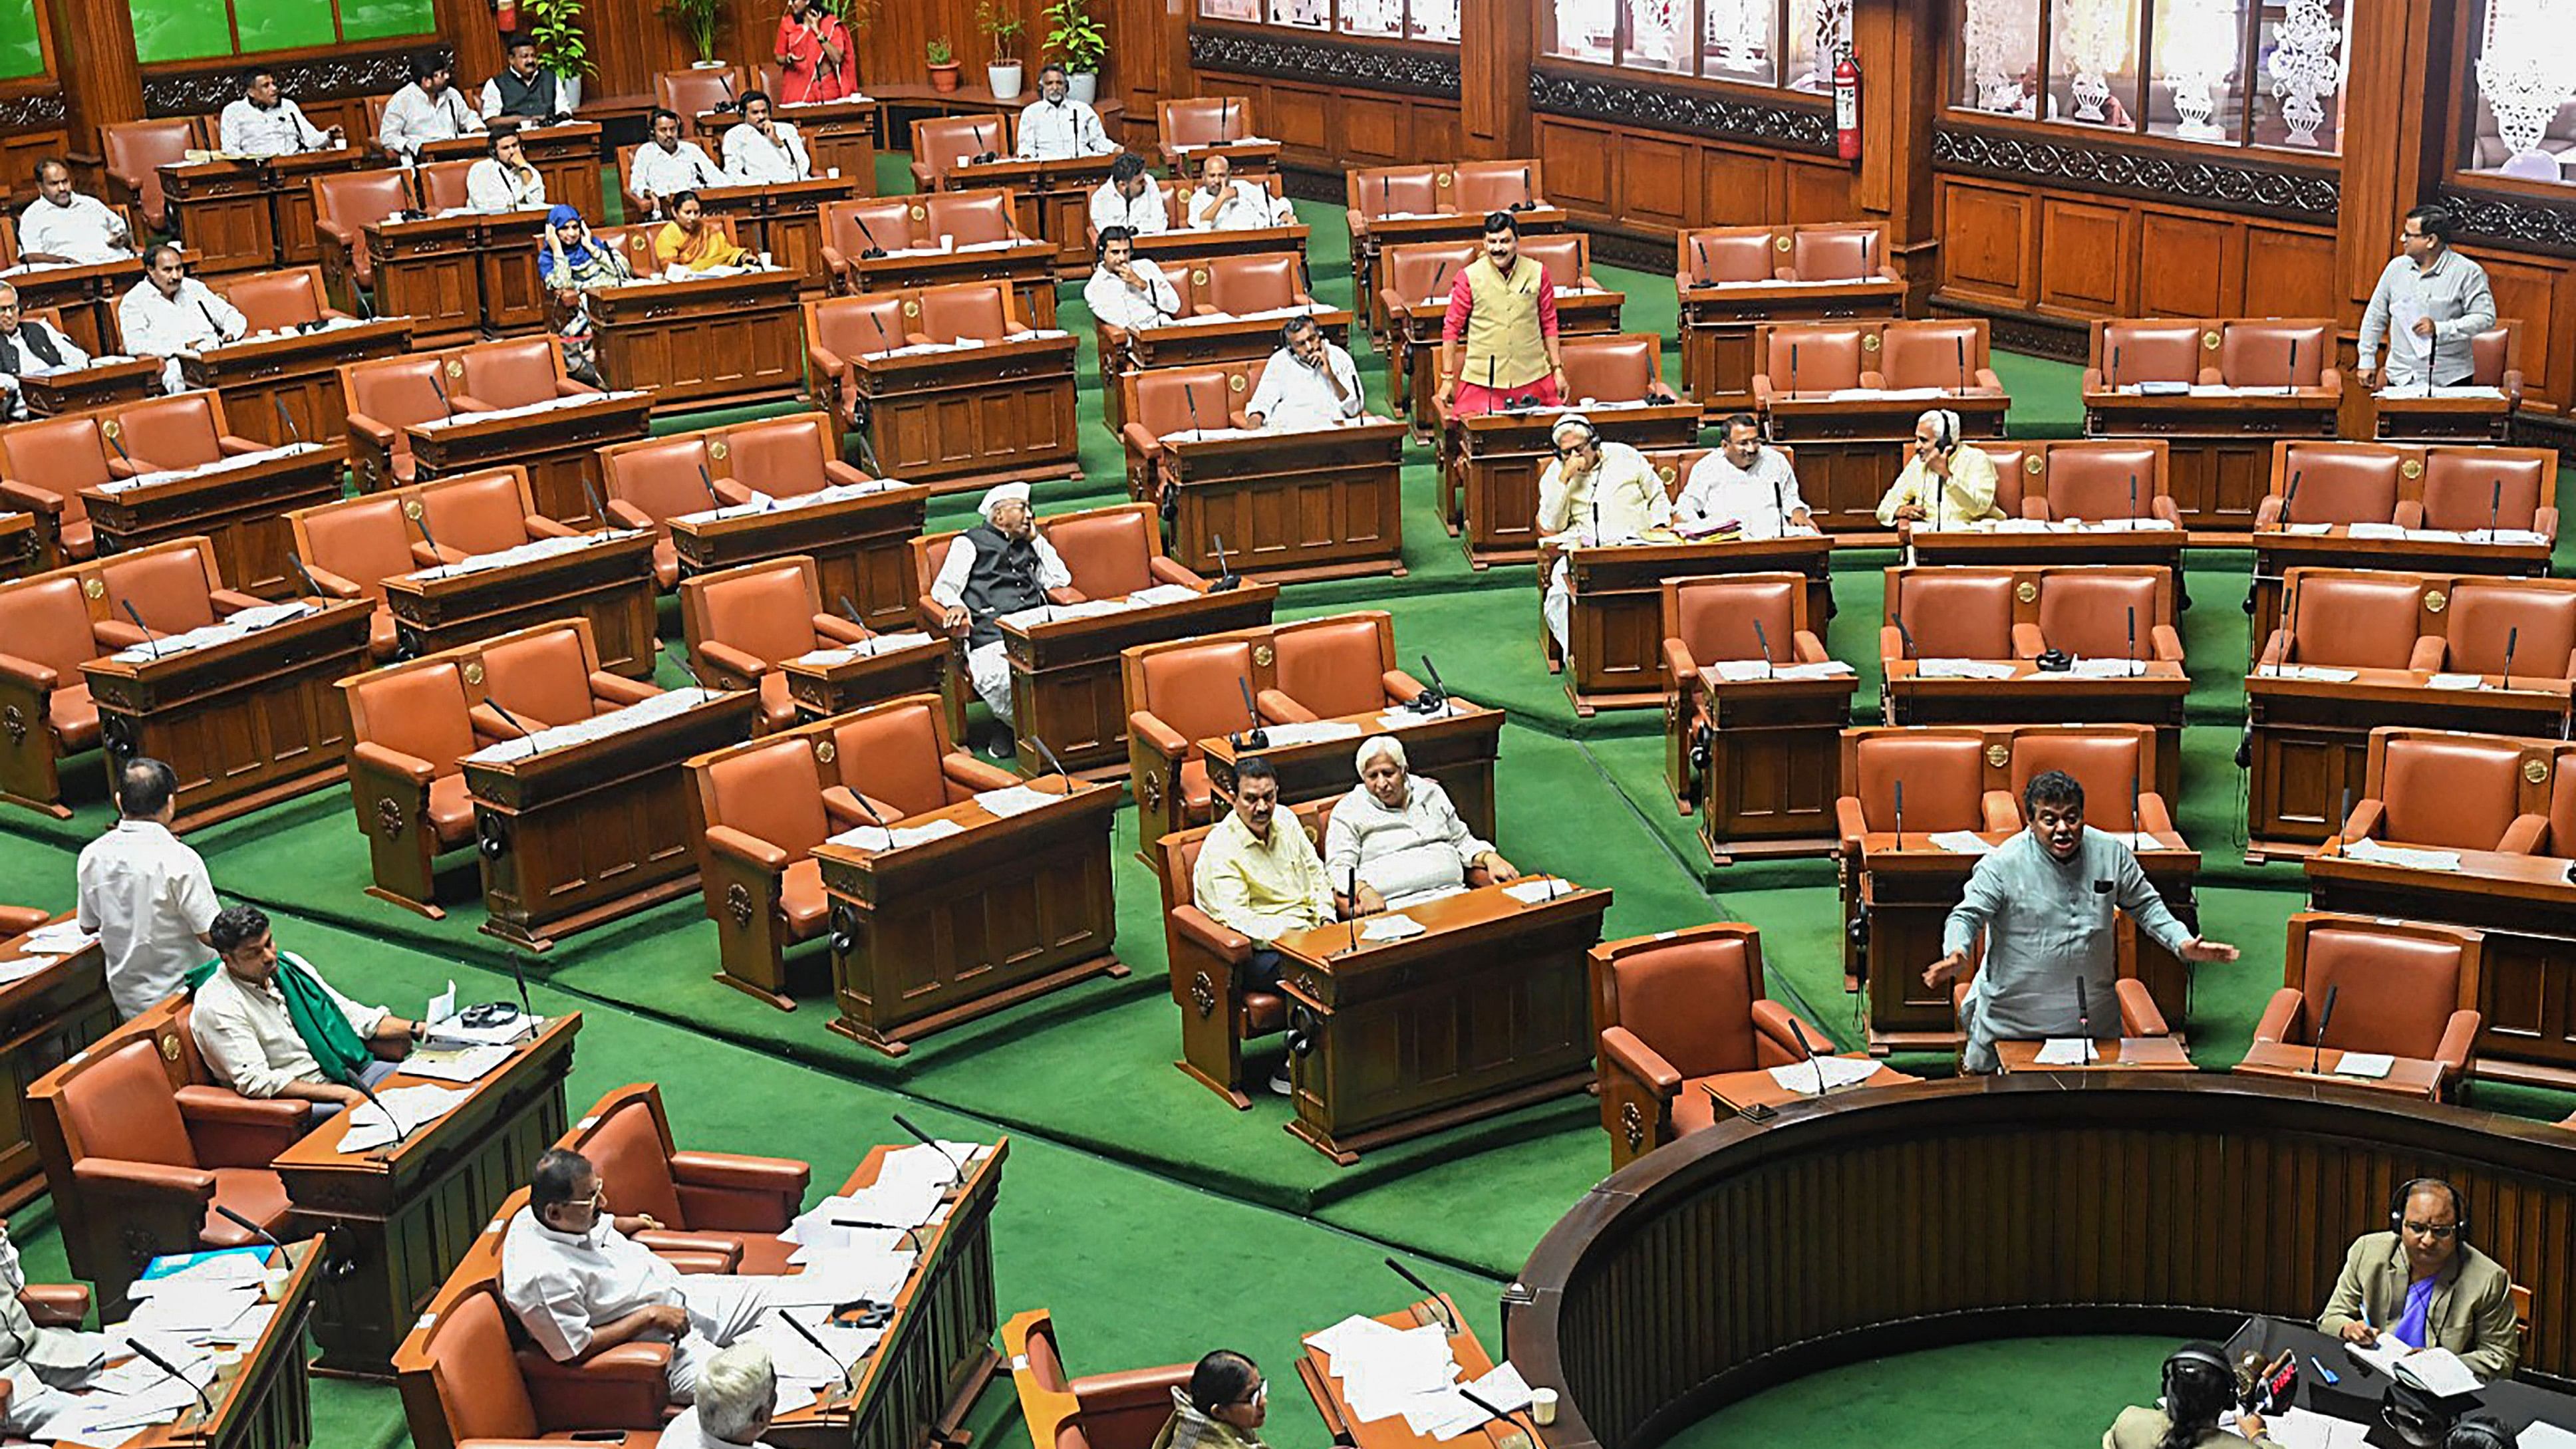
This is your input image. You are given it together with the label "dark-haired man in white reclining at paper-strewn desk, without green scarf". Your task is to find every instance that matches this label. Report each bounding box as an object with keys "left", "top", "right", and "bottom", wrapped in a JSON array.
[{"left": 500, "top": 1148, "right": 770, "bottom": 1402}]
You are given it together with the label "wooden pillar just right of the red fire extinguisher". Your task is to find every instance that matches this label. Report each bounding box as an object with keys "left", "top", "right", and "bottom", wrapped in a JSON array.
[{"left": 1852, "top": 0, "right": 1950, "bottom": 317}]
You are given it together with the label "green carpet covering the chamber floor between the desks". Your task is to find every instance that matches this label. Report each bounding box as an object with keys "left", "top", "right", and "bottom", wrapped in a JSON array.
[{"left": 0, "top": 154, "right": 2568, "bottom": 1449}]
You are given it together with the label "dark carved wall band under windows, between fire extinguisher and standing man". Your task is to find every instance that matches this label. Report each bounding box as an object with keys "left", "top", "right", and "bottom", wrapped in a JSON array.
[{"left": 1932, "top": 126, "right": 2342, "bottom": 227}]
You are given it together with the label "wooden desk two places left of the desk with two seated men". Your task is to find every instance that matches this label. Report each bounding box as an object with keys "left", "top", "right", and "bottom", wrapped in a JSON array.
[{"left": 461, "top": 690, "right": 760, "bottom": 950}]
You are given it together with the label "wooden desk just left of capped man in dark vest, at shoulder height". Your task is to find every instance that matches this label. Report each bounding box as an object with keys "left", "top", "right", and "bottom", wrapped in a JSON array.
[{"left": 670, "top": 479, "right": 930, "bottom": 635}]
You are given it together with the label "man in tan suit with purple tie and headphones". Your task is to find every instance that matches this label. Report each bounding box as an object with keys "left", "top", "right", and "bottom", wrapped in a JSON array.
[{"left": 2316, "top": 1176, "right": 2522, "bottom": 1380}]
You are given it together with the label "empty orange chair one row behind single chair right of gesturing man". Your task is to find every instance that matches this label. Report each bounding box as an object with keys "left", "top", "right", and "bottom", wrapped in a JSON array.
[{"left": 2339, "top": 728, "right": 2550, "bottom": 855}]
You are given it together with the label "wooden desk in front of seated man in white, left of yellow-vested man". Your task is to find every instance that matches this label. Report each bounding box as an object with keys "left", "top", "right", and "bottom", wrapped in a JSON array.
[{"left": 1159, "top": 417, "right": 1404, "bottom": 585}]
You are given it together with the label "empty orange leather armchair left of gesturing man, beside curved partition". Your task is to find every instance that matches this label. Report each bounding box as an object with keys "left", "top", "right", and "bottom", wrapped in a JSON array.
[{"left": 1590, "top": 922, "right": 1834, "bottom": 1166}]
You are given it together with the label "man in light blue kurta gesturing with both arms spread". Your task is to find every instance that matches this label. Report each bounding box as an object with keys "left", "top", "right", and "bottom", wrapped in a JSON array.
[{"left": 1924, "top": 769, "right": 2236, "bottom": 1071}]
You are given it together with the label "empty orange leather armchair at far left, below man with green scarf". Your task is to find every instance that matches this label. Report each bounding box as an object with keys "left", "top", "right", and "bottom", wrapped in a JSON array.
[{"left": 26, "top": 996, "right": 307, "bottom": 1318}]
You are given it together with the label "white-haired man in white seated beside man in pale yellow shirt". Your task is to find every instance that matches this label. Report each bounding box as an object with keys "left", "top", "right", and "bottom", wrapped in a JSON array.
[{"left": 1324, "top": 733, "right": 1520, "bottom": 916}]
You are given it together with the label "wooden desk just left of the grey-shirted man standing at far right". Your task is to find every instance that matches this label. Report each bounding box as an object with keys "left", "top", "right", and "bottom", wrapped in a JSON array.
[{"left": 2084, "top": 384, "right": 2339, "bottom": 543}]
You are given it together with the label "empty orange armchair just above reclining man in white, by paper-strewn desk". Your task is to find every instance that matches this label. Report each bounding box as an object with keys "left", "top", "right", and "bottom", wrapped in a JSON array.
[{"left": 557, "top": 1083, "right": 814, "bottom": 1274}]
